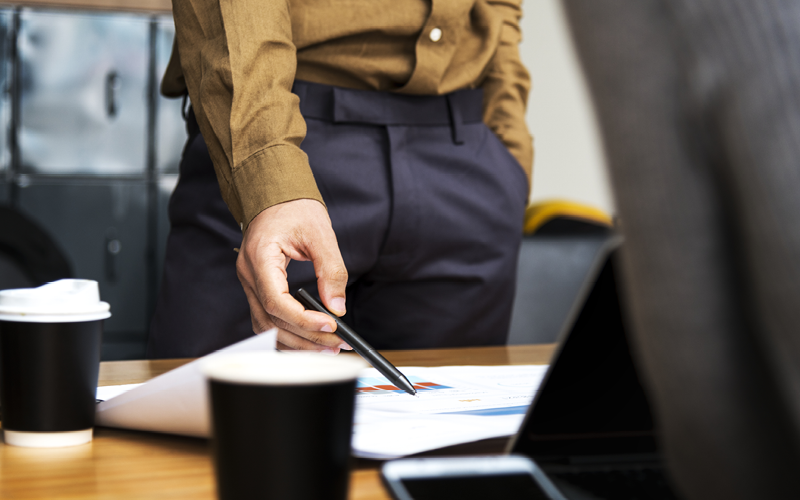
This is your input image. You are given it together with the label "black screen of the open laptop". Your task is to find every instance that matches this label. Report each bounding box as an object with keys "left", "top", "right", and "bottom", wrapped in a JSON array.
[{"left": 511, "top": 245, "right": 657, "bottom": 461}]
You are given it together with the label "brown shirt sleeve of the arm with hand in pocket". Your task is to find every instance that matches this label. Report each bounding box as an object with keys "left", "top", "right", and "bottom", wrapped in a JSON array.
[{"left": 481, "top": 0, "right": 533, "bottom": 189}]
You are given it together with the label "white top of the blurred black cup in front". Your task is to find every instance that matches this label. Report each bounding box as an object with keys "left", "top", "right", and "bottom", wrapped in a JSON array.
[{"left": 202, "top": 351, "right": 367, "bottom": 385}]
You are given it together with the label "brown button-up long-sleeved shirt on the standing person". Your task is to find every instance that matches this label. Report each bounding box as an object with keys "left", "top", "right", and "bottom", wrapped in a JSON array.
[{"left": 162, "top": 0, "right": 533, "bottom": 230}]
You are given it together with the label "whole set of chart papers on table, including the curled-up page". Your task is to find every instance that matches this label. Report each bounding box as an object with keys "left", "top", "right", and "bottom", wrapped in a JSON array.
[{"left": 90, "top": 333, "right": 547, "bottom": 458}]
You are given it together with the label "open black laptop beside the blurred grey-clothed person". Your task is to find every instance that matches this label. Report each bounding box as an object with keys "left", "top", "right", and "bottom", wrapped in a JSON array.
[{"left": 508, "top": 240, "right": 678, "bottom": 500}]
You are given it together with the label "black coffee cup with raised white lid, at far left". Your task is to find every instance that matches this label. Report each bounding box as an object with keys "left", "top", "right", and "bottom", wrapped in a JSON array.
[{"left": 0, "top": 280, "right": 110, "bottom": 447}]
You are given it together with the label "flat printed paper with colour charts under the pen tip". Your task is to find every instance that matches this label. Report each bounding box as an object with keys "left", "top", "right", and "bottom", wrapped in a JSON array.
[{"left": 353, "top": 365, "right": 547, "bottom": 458}]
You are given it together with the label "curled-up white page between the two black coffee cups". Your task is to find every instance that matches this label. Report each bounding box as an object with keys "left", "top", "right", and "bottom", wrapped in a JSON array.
[{"left": 95, "top": 329, "right": 277, "bottom": 437}]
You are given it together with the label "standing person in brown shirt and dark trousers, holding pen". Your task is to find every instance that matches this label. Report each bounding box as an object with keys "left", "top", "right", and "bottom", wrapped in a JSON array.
[{"left": 148, "top": 0, "right": 533, "bottom": 357}]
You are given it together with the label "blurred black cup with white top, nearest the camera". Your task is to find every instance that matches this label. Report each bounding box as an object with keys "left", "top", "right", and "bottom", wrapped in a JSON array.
[{"left": 203, "top": 352, "right": 366, "bottom": 500}]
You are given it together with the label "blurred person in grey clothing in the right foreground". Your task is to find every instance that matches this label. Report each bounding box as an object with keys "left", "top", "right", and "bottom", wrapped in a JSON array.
[{"left": 565, "top": 0, "right": 800, "bottom": 500}]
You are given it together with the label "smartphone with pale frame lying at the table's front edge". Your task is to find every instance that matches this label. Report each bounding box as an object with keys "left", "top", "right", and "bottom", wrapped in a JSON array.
[{"left": 381, "top": 455, "right": 566, "bottom": 500}]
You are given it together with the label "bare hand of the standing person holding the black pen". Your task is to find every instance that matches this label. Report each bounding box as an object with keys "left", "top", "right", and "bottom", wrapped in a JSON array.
[{"left": 236, "top": 200, "right": 350, "bottom": 353}]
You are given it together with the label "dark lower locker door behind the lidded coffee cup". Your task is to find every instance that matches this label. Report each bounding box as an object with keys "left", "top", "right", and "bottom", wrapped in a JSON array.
[{"left": 19, "top": 179, "right": 147, "bottom": 337}]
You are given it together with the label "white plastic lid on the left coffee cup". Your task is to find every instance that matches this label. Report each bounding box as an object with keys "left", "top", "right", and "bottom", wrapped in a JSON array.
[{"left": 0, "top": 280, "right": 111, "bottom": 323}]
